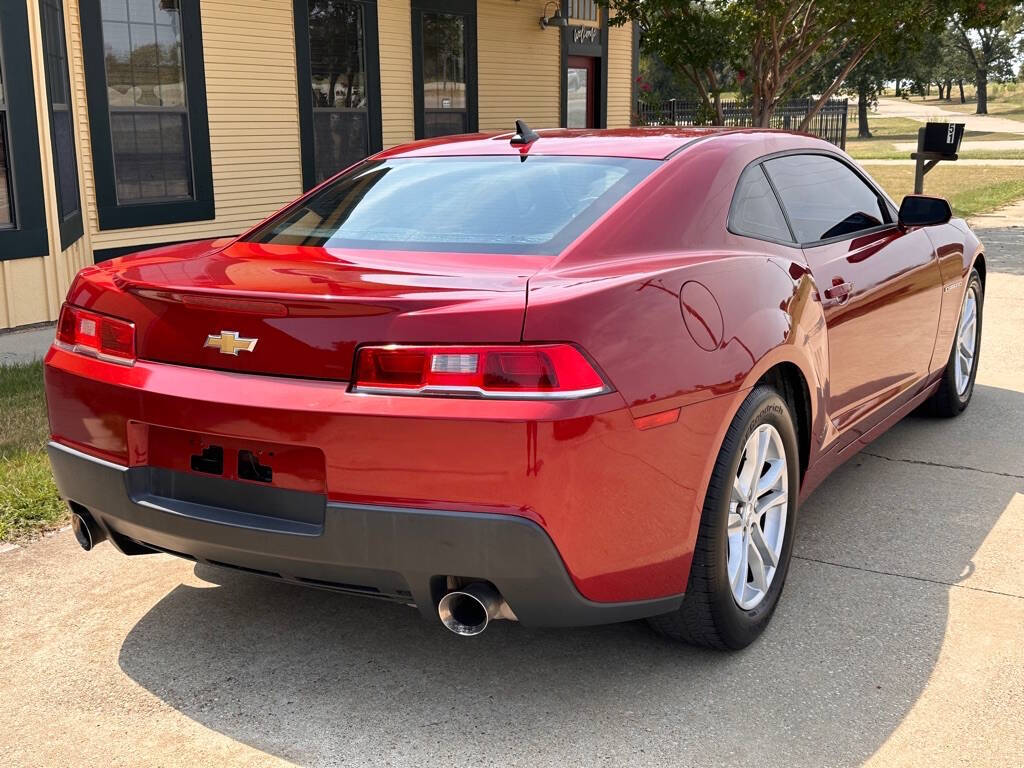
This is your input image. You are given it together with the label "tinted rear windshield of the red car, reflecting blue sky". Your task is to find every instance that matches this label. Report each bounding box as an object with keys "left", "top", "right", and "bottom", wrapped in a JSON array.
[{"left": 249, "top": 156, "right": 658, "bottom": 254}]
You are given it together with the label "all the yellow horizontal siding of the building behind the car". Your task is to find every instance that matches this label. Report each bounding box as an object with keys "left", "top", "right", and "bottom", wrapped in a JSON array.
[{"left": 0, "top": 0, "right": 633, "bottom": 329}]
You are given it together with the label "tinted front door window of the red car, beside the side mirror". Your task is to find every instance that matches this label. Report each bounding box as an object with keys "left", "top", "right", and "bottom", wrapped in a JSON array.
[{"left": 765, "top": 155, "right": 891, "bottom": 243}]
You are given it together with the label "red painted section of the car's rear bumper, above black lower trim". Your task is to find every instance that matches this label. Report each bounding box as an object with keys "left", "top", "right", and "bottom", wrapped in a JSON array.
[{"left": 44, "top": 347, "right": 742, "bottom": 603}]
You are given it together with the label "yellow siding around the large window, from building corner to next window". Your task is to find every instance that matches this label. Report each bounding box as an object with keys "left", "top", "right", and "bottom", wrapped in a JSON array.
[{"left": 65, "top": 0, "right": 302, "bottom": 250}]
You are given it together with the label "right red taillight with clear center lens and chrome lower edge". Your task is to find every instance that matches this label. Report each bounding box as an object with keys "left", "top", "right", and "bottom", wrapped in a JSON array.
[{"left": 352, "top": 344, "right": 610, "bottom": 398}]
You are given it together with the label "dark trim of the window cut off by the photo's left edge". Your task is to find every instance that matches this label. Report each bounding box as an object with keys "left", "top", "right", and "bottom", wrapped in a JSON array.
[{"left": 0, "top": 2, "right": 50, "bottom": 261}]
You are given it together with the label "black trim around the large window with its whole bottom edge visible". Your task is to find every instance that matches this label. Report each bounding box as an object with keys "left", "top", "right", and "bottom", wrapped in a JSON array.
[{"left": 79, "top": 0, "right": 216, "bottom": 230}]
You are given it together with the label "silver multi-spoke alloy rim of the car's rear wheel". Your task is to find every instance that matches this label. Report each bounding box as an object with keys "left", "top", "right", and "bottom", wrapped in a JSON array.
[{"left": 727, "top": 424, "right": 790, "bottom": 610}]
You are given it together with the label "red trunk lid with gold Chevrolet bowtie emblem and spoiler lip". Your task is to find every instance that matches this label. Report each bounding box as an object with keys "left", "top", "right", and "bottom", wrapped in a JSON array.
[{"left": 96, "top": 242, "right": 549, "bottom": 381}]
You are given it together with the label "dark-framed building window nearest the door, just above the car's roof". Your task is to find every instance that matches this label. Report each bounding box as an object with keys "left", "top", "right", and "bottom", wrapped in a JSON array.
[{"left": 413, "top": 0, "right": 477, "bottom": 138}]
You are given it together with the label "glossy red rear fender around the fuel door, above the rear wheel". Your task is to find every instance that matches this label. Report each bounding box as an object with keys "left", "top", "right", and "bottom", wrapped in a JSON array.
[{"left": 523, "top": 253, "right": 828, "bottom": 520}]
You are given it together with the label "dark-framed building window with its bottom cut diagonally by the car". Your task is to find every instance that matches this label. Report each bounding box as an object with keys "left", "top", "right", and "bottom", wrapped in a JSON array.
[{"left": 295, "top": 0, "right": 381, "bottom": 188}]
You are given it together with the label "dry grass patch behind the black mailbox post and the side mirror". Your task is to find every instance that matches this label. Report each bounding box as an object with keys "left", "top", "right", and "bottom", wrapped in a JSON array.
[{"left": 867, "top": 163, "right": 1024, "bottom": 218}]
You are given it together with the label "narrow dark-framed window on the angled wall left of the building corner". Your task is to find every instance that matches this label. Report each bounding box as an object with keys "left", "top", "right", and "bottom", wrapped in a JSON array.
[{"left": 39, "top": 0, "right": 82, "bottom": 249}]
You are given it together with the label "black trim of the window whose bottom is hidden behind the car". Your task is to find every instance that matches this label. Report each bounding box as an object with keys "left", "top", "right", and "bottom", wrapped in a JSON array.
[{"left": 294, "top": 0, "right": 384, "bottom": 191}]
